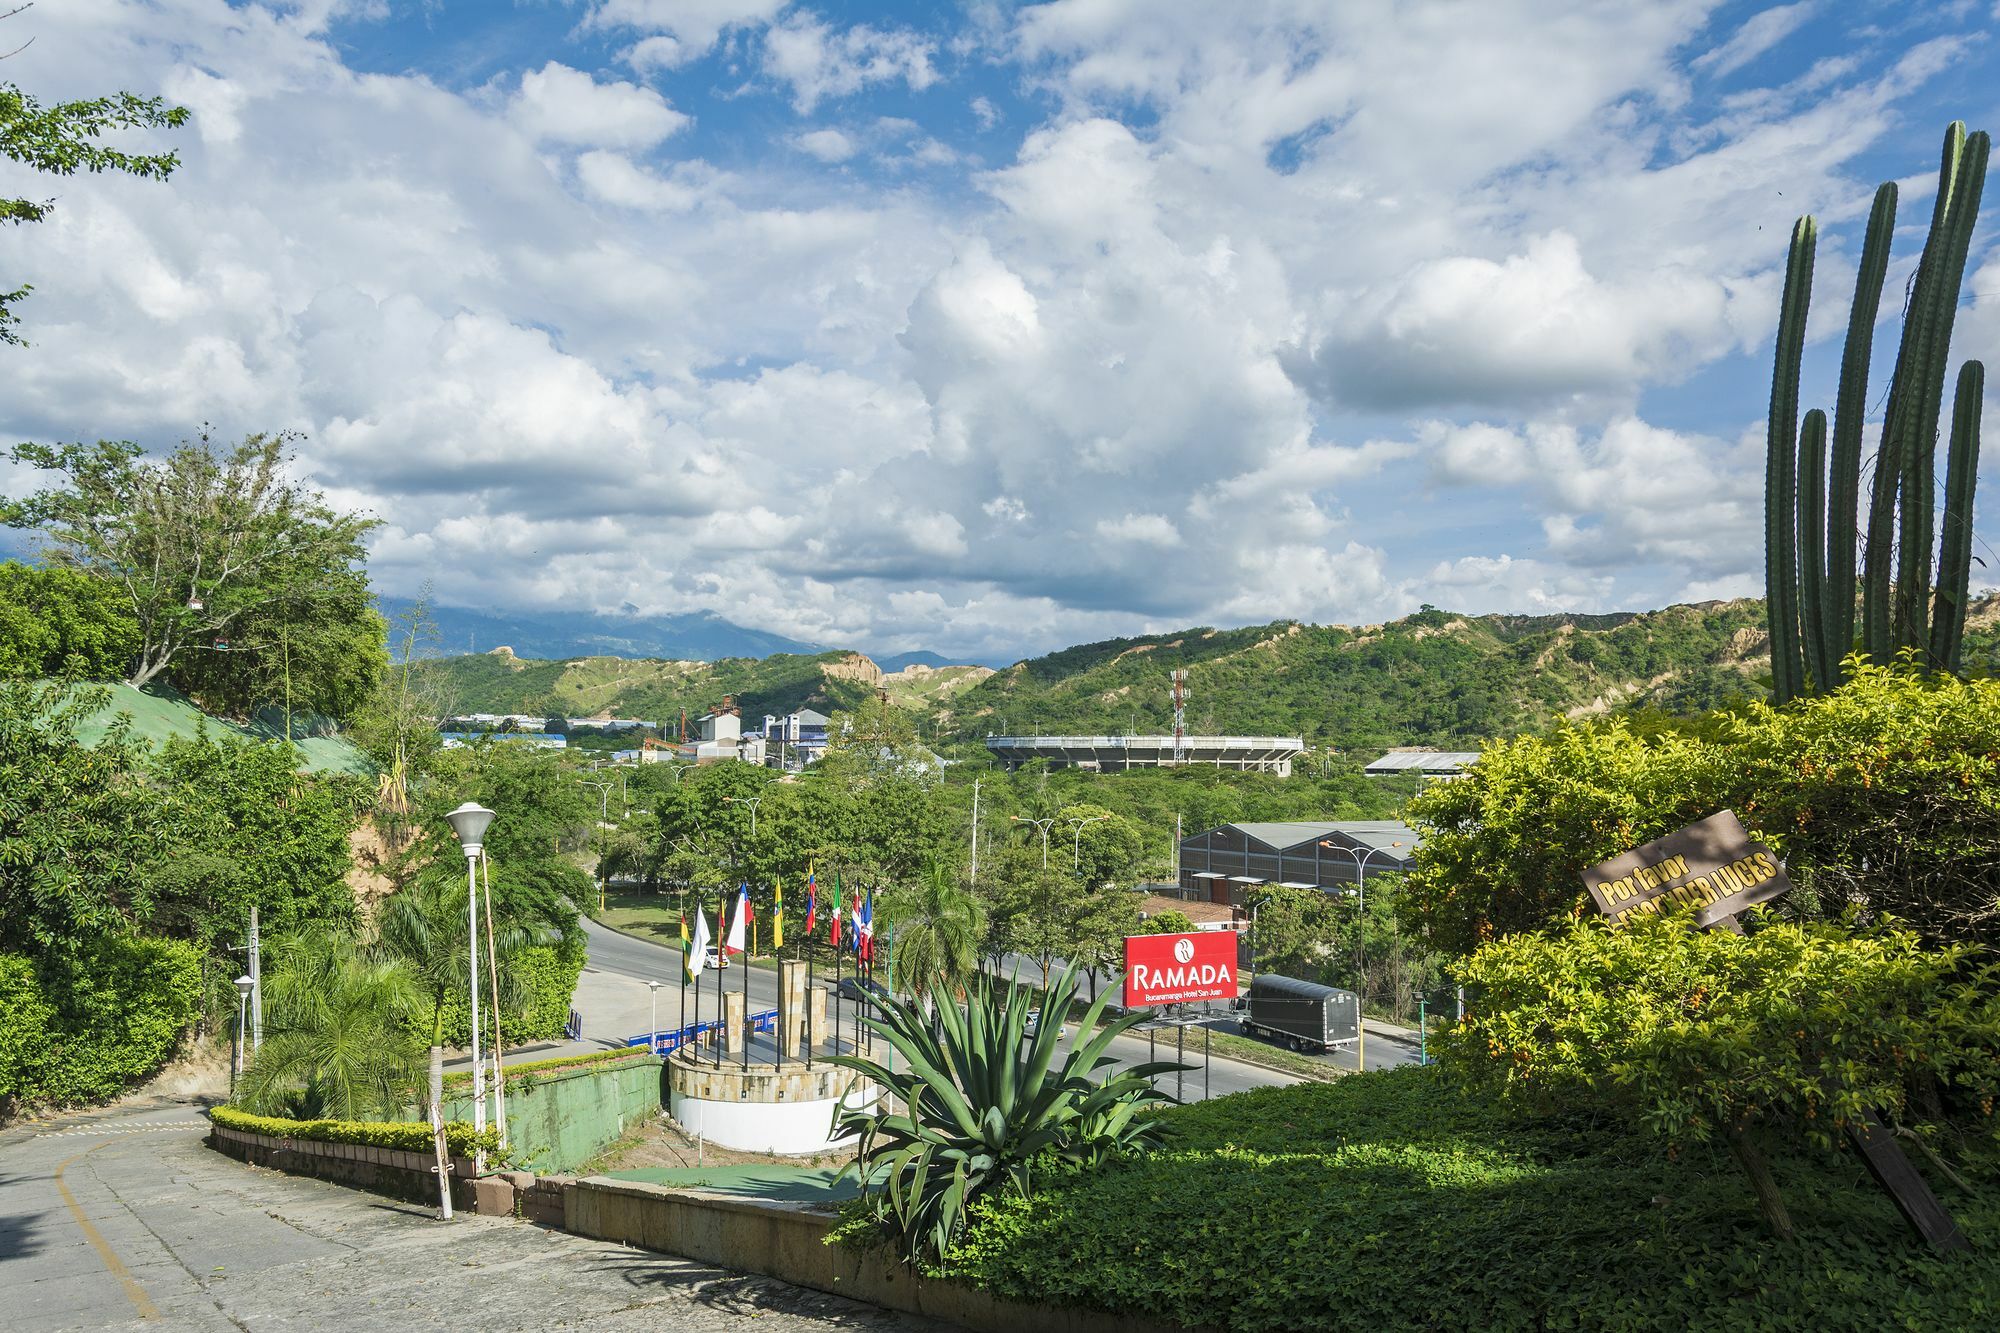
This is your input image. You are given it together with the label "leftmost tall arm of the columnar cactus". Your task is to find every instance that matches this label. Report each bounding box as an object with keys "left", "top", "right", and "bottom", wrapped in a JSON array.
[{"left": 1764, "top": 216, "right": 1818, "bottom": 703}]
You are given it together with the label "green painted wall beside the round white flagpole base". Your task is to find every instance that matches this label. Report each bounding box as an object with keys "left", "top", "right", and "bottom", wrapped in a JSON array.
[{"left": 444, "top": 1059, "right": 664, "bottom": 1175}]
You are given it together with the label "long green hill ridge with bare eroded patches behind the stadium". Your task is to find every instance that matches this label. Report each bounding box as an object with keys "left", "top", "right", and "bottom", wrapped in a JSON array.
[{"left": 406, "top": 594, "right": 2000, "bottom": 747}]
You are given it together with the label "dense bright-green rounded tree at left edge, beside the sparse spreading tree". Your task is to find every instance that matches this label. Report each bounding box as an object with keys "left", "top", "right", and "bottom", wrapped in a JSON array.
[{"left": 0, "top": 560, "right": 138, "bottom": 681}]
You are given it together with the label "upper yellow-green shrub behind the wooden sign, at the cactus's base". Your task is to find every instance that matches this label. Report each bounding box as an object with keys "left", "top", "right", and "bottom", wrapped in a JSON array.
[{"left": 1404, "top": 667, "right": 2000, "bottom": 957}]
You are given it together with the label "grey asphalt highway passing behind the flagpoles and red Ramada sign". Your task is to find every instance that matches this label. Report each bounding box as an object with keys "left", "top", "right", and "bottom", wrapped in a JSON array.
[{"left": 568, "top": 919, "right": 1296, "bottom": 1101}]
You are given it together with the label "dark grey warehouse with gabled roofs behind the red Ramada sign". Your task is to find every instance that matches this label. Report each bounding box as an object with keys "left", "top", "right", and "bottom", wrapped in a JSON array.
[{"left": 1180, "top": 819, "right": 1422, "bottom": 907}]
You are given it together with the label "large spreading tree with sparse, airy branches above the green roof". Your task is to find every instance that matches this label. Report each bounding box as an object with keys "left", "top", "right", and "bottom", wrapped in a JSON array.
[{"left": 0, "top": 434, "right": 380, "bottom": 697}]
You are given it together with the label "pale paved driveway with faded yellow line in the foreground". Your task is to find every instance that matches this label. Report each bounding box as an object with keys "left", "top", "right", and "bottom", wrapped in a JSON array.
[{"left": 0, "top": 1107, "right": 940, "bottom": 1333}]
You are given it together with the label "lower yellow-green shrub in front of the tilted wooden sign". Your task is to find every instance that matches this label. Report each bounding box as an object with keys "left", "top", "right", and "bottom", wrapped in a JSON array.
[{"left": 1434, "top": 915, "right": 2000, "bottom": 1147}]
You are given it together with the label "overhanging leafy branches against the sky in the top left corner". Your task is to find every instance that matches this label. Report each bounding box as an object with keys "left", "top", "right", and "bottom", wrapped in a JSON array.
[{"left": 0, "top": 39, "right": 188, "bottom": 344}]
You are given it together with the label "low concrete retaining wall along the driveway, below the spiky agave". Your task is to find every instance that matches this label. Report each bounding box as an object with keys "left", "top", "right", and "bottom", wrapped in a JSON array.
[{"left": 562, "top": 1177, "right": 1180, "bottom": 1333}]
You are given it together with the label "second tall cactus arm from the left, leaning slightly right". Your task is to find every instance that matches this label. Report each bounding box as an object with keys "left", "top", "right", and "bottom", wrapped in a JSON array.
[{"left": 1820, "top": 180, "right": 1896, "bottom": 689}]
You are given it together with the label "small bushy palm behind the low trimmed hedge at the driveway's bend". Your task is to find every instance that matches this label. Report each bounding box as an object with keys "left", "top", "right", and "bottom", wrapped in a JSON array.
[{"left": 238, "top": 929, "right": 422, "bottom": 1121}]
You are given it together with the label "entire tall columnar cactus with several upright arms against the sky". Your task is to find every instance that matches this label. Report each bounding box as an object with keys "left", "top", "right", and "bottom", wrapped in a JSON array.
[{"left": 1764, "top": 122, "right": 1990, "bottom": 703}]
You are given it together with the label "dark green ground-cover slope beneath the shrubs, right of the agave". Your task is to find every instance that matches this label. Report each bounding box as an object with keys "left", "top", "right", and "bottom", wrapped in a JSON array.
[{"left": 944, "top": 1069, "right": 2000, "bottom": 1333}]
